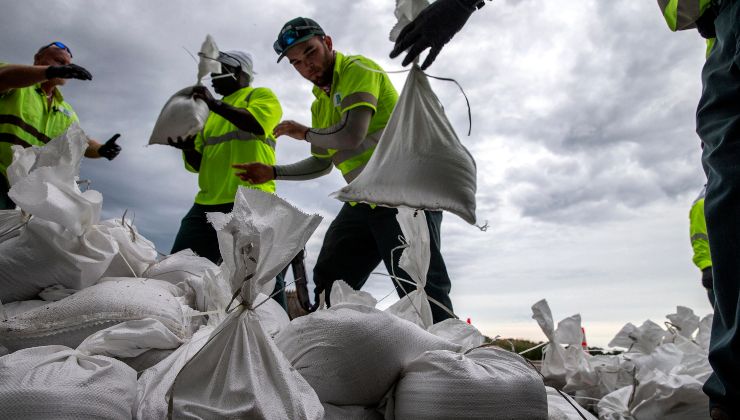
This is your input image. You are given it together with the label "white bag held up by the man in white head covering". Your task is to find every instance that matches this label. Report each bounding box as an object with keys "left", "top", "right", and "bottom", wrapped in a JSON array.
[{"left": 149, "top": 35, "right": 221, "bottom": 145}]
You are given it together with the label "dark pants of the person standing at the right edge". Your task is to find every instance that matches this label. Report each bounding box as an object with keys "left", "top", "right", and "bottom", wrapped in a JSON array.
[{"left": 697, "top": 0, "right": 740, "bottom": 418}]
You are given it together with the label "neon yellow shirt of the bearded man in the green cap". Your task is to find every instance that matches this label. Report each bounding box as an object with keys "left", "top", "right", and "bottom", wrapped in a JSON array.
[{"left": 311, "top": 52, "right": 398, "bottom": 179}]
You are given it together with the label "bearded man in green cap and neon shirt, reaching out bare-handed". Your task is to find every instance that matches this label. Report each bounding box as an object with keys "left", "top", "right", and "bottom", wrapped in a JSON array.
[{"left": 235, "top": 17, "right": 452, "bottom": 322}]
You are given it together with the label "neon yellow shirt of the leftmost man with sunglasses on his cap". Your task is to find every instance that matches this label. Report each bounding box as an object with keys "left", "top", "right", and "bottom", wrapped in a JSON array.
[{"left": 0, "top": 63, "right": 79, "bottom": 176}]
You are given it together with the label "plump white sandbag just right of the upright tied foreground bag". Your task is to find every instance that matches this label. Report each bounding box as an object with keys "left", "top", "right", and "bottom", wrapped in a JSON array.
[{"left": 275, "top": 304, "right": 460, "bottom": 406}]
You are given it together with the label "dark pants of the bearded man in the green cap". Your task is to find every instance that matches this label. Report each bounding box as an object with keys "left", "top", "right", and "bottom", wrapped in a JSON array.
[{"left": 313, "top": 204, "right": 452, "bottom": 323}]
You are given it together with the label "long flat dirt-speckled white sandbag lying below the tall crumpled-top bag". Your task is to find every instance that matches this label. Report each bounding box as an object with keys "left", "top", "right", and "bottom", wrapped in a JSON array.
[{"left": 0, "top": 279, "right": 189, "bottom": 351}]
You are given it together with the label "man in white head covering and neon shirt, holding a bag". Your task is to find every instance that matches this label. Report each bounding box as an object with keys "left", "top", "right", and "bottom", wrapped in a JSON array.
[{"left": 168, "top": 51, "right": 287, "bottom": 308}]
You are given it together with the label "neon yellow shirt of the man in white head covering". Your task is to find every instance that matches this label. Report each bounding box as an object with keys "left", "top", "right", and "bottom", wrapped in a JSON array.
[{"left": 183, "top": 86, "right": 283, "bottom": 205}]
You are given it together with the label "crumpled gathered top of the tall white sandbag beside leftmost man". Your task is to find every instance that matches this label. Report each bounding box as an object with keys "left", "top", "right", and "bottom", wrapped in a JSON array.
[{"left": 8, "top": 123, "right": 103, "bottom": 236}]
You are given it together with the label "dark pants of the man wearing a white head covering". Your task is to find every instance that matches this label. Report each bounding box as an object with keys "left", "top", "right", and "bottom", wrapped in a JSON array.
[{"left": 170, "top": 203, "right": 288, "bottom": 311}]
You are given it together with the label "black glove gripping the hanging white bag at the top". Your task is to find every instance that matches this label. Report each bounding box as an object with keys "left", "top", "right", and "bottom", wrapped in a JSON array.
[{"left": 391, "top": 0, "right": 483, "bottom": 70}]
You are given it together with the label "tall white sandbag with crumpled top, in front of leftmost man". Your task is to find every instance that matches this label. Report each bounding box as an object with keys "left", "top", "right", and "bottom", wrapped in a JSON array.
[{"left": 0, "top": 124, "right": 119, "bottom": 302}]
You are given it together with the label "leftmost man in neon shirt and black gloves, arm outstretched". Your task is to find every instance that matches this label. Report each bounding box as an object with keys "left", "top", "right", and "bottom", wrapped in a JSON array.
[{"left": 0, "top": 42, "right": 121, "bottom": 210}]
